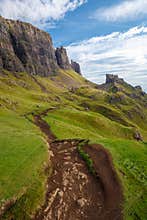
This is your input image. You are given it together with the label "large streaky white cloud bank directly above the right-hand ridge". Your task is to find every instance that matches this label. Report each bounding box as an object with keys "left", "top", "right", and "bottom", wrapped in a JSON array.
[{"left": 67, "top": 27, "right": 147, "bottom": 91}]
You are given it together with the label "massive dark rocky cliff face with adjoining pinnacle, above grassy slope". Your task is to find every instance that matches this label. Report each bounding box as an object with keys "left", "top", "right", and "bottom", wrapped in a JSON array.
[{"left": 0, "top": 17, "right": 79, "bottom": 76}]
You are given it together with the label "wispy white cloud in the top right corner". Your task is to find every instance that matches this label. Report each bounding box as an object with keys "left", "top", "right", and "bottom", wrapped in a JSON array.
[{"left": 93, "top": 0, "right": 147, "bottom": 21}]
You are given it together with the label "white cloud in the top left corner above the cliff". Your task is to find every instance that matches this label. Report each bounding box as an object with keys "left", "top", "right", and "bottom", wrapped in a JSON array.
[{"left": 0, "top": 0, "right": 86, "bottom": 26}]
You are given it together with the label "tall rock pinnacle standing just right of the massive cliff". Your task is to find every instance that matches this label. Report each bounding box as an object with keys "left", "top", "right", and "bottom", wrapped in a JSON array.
[{"left": 55, "top": 47, "right": 71, "bottom": 70}]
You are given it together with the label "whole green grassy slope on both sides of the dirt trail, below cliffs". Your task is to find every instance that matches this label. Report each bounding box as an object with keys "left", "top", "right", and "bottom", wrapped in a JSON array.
[{"left": 0, "top": 71, "right": 147, "bottom": 220}]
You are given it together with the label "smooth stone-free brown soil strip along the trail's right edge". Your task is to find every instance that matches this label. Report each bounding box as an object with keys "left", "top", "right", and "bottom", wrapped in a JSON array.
[{"left": 84, "top": 144, "right": 123, "bottom": 220}]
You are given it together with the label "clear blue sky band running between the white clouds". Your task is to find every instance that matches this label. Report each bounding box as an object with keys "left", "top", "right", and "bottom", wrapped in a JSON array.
[{"left": 49, "top": 0, "right": 147, "bottom": 46}]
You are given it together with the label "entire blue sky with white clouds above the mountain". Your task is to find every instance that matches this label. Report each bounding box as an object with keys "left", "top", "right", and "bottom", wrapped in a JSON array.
[{"left": 0, "top": 0, "right": 147, "bottom": 91}]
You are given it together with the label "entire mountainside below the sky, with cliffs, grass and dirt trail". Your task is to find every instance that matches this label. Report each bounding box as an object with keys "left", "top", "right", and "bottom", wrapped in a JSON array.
[{"left": 0, "top": 17, "right": 147, "bottom": 220}]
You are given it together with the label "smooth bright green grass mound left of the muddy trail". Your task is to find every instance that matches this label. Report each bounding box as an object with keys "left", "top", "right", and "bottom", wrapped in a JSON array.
[{"left": 0, "top": 109, "right": 48, "bottom": 219}]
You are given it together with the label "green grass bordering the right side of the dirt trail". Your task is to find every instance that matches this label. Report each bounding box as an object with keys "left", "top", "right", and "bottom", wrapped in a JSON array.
[{"left": 45, "top": 109, "right": 147, "bottom": 220}]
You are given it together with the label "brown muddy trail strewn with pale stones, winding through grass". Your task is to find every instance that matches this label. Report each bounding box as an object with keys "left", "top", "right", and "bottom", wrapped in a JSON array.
[{"left": 34, "top": 115, "right": 123, "bottom": 220}]
